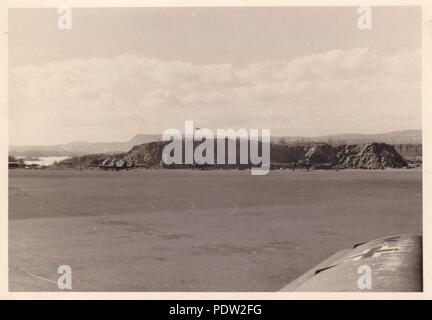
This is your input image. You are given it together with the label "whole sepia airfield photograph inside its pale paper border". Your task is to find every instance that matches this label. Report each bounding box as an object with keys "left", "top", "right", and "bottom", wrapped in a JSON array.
[{"left": 7, "top": 6, "right": 426, "bottom": 292}]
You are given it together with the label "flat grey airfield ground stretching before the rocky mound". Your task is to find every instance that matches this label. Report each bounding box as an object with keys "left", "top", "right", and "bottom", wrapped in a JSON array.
[{"left": 9, "top": 169, "right": 422, "bottom": 291}]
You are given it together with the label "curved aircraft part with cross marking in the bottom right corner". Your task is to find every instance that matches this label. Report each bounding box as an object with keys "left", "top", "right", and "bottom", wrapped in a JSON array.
[{"left": 281, "top": 235, "right": 423, "bottom": 292}]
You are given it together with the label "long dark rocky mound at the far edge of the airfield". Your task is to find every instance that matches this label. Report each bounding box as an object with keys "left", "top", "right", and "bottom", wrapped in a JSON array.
[{"left": 56, "top": 141, "right": 407, "bottom": 169}]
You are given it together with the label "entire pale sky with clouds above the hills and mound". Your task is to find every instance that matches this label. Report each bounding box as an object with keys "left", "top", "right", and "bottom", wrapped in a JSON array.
[{"left": 8, "top": 7, "right": 421, "bottom": 145}]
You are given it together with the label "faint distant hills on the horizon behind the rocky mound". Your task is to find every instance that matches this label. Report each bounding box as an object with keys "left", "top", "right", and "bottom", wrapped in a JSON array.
[{"left": 9, "top": 130, "right": 422, "bottom": 157}]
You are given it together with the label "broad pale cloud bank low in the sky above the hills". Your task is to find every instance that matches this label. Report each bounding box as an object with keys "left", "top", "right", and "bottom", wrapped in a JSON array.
[{"left": 9, "top": 48, "right": 421, "bottom": 144}]
